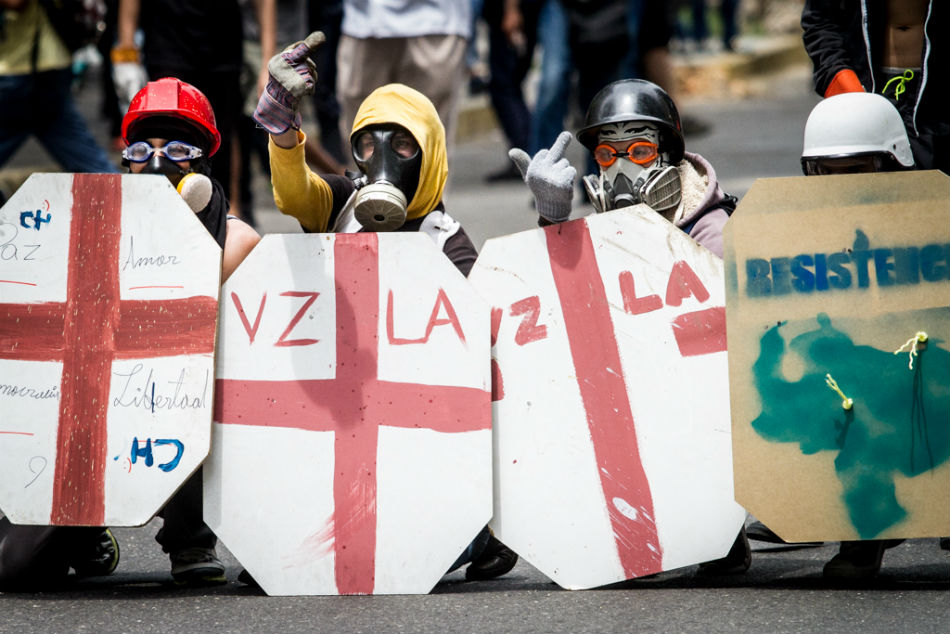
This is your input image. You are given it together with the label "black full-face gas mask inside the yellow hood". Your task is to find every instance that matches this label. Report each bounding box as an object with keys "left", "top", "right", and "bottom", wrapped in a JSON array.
[{"left": 351, "top": 124, "right": 422, "bottom": 231}]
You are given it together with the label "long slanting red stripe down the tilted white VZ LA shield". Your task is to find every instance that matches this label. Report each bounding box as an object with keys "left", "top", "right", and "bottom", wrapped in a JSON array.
[{"left": 544, "top": 220, "right": 663, "bottom": 578}]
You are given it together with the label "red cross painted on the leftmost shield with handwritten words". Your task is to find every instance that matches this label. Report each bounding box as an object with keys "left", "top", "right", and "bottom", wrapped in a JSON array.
[{"left": 0, "top": 174, "right": 217, "bottom": 526}]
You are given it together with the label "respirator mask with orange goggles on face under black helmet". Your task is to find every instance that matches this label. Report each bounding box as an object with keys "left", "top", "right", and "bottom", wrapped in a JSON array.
[{"left": 583, "top": 121, "right": 682, "bottom": 219}]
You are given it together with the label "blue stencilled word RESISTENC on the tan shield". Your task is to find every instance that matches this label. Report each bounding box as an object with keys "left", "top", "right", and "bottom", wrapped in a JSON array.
[{"left": 745, "top": 230, "right": 950, "bottom": 297}]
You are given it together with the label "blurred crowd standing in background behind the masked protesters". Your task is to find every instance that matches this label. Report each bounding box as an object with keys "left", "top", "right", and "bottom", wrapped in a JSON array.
[{"left": 0, "top": 0, "right": 804, "bottom": 225}]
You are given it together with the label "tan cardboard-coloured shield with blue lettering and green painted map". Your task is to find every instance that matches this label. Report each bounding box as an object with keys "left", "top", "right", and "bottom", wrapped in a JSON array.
[{"left": 726, "top": 171, "right": 950, "bottom": 541}]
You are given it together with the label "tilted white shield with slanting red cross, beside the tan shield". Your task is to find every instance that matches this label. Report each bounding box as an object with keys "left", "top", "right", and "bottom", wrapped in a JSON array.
[{"left": 469, "top": 207, "right": 745, "bottom": 588}]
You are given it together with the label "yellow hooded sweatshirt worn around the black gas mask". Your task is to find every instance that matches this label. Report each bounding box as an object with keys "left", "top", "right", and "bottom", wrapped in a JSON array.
[{"left": 268, "top": 84, "right": 449, "bottom": 233}]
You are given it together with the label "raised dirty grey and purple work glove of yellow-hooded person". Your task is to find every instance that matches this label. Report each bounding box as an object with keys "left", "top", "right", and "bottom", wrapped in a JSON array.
[{"left": 254, "top": 31, "right": 326, "bottom": 134}]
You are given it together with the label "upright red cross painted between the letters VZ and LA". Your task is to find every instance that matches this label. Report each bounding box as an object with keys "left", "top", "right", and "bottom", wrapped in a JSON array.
[{"left": 215, "top": 233, "right": 491, "bottom": 594}]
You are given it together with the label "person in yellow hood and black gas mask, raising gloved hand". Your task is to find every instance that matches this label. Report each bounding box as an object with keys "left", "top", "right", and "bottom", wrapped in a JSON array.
[{"left": 254, "top": 34, "right": 478, "bottom": 275}]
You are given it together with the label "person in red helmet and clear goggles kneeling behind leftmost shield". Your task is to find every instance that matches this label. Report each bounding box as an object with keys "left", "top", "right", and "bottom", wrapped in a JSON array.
[{"left": 0, "top": 78, "right": 260, "bottom": 590}]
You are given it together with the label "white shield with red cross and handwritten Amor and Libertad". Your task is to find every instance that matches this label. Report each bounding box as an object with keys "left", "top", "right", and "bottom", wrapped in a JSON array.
[{"left": 0, "top": 174, "right": 221, "bottom": 526}]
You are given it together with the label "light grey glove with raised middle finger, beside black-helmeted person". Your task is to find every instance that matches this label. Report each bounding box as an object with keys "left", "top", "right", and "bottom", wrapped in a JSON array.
[{"left": 508, "top": 130, "right": 577, "bottom": 222}]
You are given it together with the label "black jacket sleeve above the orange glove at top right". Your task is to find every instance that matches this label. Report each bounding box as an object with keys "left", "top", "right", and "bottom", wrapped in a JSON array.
[{"left": 802, "top": 0, "right": 865, "bottom": 97}]
